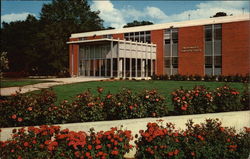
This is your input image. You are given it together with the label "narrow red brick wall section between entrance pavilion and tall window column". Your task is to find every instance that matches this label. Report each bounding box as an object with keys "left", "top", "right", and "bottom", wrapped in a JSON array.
[{"left": 151, "top": 30, "right": 164, "bottom": 75}]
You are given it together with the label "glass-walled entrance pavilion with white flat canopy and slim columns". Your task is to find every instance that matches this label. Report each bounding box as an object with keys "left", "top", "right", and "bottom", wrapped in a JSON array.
[{"left": 67, "top": 38, "right": 156, "bottom": 78}]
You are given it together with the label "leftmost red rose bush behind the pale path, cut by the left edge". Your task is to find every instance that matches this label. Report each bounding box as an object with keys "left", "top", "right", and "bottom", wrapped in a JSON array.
[{"left": 0, "top": 90, "right": 56, "bottom": 127}]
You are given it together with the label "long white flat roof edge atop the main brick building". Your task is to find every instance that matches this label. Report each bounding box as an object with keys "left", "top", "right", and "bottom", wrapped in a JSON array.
[{"left": 70, "top": 14, "right": 250, "bottom": 38}]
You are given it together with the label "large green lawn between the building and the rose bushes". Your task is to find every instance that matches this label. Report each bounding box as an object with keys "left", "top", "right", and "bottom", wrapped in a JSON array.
[{"left": 47, "top": 80, "right": 247, "bottom": 109}]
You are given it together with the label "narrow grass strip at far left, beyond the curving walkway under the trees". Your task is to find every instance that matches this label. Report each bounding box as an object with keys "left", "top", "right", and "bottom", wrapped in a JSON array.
[{"left": 1, "top": 79, "right": 52, "bottom": 88}]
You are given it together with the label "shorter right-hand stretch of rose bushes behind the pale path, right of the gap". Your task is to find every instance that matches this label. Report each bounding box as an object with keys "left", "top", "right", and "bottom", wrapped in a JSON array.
[{"left": 172, "top": 85, "right": 250, "bottom": 114}]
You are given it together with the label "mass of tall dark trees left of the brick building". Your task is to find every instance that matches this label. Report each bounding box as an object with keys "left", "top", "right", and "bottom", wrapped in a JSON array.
[{"left": 1, "top": 0, "right": 103, "bottom": 74}]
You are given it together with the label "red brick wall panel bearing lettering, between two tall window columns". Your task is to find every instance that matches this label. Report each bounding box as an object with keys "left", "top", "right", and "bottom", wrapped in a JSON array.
[{"left": 178, "top": 26, "right": 205, "bottom": 76}]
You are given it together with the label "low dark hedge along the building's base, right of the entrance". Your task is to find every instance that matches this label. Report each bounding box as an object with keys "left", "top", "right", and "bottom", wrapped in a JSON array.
[{"left": 151, "top": 74, "right": 250, "bottom": 83}]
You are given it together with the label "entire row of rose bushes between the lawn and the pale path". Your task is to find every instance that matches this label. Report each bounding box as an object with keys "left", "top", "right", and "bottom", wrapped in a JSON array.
[{"left": 0, "top": 86, "right": 249, "bottom": 127}]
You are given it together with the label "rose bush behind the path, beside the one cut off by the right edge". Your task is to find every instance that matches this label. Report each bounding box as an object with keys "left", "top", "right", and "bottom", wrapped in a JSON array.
[{"left": 214, "top": 85, "right": 242, "bottom": 111}]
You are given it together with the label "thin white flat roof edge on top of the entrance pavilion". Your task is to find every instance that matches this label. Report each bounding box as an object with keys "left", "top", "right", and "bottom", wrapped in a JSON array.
[{"left": 67, "top": 38, "right": 156, "bottom": 46}]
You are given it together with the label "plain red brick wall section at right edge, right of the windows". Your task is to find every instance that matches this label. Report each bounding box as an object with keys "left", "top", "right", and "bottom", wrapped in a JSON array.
[{"left": 222, "top": 21, "right": 250, "bottom": 75}]
